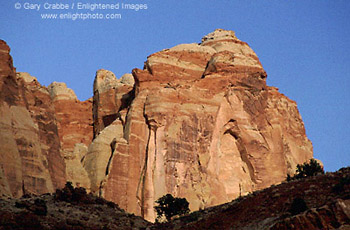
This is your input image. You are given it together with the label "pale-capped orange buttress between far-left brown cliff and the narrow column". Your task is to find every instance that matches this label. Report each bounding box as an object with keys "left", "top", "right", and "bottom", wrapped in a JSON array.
[{"left": 48, "top": 82, "right": 93, "bottom": 190}]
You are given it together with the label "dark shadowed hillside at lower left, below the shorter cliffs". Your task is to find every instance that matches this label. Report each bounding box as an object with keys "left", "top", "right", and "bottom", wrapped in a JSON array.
[{"left": 0, "top": 190, "right": 151, "bottom": 230}]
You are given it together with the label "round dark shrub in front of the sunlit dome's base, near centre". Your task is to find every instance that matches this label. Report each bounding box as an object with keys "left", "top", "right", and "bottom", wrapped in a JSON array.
[{"left": 154, "top": 194, "right": 190, "bottom": 221}]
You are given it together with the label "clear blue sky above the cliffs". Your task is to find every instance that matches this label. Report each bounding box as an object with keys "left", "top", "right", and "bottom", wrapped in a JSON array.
[{"left": 0, "top": 0, "right": 350, "bottom": 171}]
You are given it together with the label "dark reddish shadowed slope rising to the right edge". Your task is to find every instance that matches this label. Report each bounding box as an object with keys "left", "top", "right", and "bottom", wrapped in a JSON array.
[{"left": 151, "top": 168, "right": 350, "bottom": 230}]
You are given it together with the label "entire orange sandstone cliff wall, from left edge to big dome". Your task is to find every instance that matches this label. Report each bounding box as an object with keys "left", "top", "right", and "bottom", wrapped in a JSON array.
[{"left": 0, "top": 30, "right": 312, "bottom": 223}]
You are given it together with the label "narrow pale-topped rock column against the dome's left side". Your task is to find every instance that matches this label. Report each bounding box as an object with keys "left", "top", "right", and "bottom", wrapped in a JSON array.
[{"left": 83, "top": 69, "right": 134, "bottom": 199}]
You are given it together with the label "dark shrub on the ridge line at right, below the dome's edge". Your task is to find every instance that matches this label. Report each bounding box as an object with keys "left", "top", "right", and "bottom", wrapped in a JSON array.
[{"left": 287, "top": 159, "right": 324, "bottom": 181}]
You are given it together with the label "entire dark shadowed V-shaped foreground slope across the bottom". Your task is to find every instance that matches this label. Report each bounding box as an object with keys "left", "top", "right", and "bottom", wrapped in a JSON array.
[{"left": 0, "top": 168, "right": 350, "bottom": 230}]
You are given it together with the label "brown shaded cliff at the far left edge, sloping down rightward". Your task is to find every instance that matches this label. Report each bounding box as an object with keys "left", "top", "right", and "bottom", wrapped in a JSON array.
[{"left": 0, "top": 41, "right": 65, "bottom": 197}]
